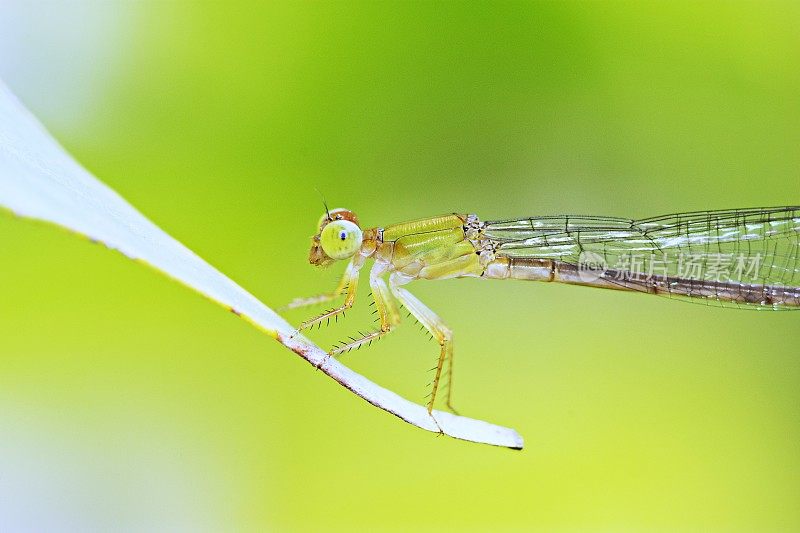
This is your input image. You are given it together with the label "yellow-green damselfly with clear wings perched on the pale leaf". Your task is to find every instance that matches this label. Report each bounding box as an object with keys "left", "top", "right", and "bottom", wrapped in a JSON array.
[{"left": 286, "top": 206, "right": 800, "bottom": 413}]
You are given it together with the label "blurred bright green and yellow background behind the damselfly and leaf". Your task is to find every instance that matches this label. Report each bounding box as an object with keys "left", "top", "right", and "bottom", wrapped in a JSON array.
[{"left": 0, "top": 0, "right": 800, "bottom": 531}]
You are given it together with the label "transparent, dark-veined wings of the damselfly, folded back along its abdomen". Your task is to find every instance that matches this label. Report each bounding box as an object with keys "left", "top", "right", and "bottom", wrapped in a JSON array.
[{"left": 484, "top": 206, "right": 800, "bottom": 309}]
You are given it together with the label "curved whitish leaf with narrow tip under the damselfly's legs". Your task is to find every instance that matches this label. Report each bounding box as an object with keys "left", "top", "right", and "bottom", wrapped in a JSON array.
[{"left": 0, "top": 82, "right": 522, "bottom": 448}]
